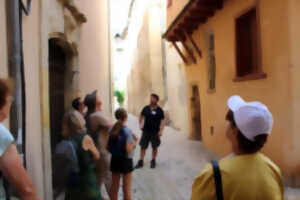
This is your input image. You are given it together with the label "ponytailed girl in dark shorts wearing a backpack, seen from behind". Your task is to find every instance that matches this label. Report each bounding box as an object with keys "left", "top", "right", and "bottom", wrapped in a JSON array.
[{"left": 108, "top": 108, "right": 138, "bottom": 200}]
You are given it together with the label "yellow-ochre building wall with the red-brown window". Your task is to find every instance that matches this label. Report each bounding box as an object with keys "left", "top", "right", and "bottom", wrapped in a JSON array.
[{"left": 168, "top": 0, "right": 300, "bottom": 183}]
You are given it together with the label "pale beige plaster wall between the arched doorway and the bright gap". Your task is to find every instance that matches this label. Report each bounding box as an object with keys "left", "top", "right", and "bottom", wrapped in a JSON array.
[{"left": 78, "top": 0, "right": 112, "bottom": 117}]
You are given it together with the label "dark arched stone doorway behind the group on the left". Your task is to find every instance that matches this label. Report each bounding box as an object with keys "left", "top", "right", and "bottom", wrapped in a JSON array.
[{"left": 49, "top": 37, "right": 79, "bottom": 153}]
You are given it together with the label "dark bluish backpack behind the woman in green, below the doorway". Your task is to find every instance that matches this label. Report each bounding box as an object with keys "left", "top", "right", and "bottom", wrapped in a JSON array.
[{"left": 52, "top": 139, "right": 80, "bottom": 198}]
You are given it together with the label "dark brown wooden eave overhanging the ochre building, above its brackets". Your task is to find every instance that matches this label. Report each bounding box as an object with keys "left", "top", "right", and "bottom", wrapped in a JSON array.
[{"left": 163, "top": 0, "right": 223, "bottom": 42}]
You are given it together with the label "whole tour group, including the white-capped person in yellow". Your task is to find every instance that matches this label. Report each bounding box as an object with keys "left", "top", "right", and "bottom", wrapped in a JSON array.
[{"left": 0, "top": 76, "right": 284, "bottom": 200}]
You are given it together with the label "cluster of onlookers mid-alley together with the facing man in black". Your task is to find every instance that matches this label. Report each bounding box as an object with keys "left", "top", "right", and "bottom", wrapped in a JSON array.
[{"left": 63, "top": 91, "right": 165, "bottom": 200}]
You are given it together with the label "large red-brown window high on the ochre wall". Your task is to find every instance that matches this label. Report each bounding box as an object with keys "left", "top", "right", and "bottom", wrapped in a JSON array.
[{"left": 235, "top": 8, "right": 262, "bottom": 80}]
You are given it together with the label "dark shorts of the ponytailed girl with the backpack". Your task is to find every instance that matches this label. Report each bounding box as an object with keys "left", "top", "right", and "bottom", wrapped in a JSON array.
[{"left": 110, "top": 156, "right": 133, "bottom": 174}]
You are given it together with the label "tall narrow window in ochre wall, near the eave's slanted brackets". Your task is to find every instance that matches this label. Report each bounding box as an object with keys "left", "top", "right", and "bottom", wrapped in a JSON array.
[{"left": 207, "top": 30, "right": 216, "bottom": 92}]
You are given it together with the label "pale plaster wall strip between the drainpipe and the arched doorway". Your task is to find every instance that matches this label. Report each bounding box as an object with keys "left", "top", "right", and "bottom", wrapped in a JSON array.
[{"left": 23, "top": 1, "right": 44, "bottom": 196}]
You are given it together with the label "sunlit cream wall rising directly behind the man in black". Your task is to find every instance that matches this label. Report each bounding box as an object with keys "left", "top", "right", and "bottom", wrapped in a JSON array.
[{"left": 127, "top": 3, "right": 166, "bottom": 115}]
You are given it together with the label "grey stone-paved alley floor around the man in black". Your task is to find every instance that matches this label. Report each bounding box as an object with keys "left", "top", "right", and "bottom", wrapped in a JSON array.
[{"left": 112, "top": 116, "right": 300, "bottom": 200}]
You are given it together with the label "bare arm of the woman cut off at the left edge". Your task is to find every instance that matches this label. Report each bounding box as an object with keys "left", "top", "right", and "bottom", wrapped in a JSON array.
[{"left": 0, "top": 144, "right": 39, "bottom": 200}]
